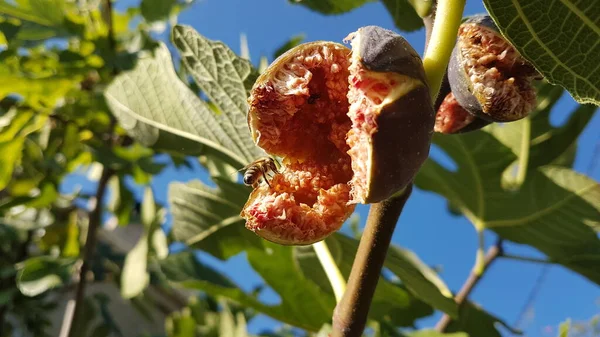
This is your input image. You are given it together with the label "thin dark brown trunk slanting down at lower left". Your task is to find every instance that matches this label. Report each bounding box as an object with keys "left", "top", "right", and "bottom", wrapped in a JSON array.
[{"left": 69, "top": 166, "right": 114, "bottom": 337}]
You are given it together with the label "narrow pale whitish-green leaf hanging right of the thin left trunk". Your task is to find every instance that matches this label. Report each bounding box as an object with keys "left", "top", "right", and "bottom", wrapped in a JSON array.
[{"left": 121, "top": 233, "right": 150, "bottom": 298}]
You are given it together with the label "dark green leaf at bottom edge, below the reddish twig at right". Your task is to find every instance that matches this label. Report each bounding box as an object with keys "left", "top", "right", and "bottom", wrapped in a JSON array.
[{"left": 446, "top": 302, "right": 522, "bottom": 337}]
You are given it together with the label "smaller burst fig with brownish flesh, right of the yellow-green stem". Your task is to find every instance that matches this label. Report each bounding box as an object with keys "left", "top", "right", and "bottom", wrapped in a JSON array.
[{"left": 448, "top": 15, "right": 540, "bottom": 122}]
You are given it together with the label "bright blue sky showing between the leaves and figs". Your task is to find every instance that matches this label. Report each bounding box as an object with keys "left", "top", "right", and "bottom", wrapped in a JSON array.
[{"left": 67, "top": 0, "right": 600, "bottom": 337}]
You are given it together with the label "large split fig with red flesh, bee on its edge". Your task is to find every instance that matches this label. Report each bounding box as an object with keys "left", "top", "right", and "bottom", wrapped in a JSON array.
[{"left": 241, "top": 26, "right": 434, "bottom": 245}]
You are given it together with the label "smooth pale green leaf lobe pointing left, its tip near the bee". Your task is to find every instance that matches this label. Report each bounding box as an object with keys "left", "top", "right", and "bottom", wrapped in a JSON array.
[{"left": 105, "top": 43, "right": 262, "bottom": 167}]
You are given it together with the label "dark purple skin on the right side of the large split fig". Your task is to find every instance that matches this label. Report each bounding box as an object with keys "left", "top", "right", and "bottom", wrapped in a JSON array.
[{"left": 346, "top": 26, "right": 435, "bottom": 204}]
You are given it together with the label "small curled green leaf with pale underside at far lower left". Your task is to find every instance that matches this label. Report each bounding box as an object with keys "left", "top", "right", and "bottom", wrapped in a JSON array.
[{"left": 17, "top": 256, "right": 75, "bottom": 296}]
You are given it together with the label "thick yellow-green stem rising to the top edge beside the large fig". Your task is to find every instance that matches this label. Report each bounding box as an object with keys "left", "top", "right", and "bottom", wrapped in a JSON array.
[{"left": 423, "top": 0, "right": 466, "bottom": 102}]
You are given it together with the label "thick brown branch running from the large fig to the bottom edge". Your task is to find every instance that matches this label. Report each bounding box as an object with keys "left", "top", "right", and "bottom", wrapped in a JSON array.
[{"left": 331, "top": 184, "right": 412, "bottom": 337}]
